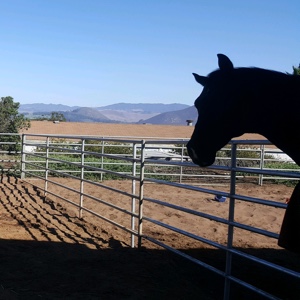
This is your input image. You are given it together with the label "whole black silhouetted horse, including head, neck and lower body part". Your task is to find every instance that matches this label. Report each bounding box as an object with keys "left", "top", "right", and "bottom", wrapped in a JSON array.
[{"left": 187, "top": 54, "right": 300, "bottom": 252}]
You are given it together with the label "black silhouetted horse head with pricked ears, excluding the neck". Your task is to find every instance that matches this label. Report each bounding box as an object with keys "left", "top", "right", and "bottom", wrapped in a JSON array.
[{"left": 187, "top": 54, "right": 248, "bottom": 167}]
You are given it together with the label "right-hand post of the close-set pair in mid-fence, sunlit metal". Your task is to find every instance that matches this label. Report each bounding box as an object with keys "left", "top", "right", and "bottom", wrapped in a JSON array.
[{"left": 138, "top": 140, "right": 146, "bottom": 248}]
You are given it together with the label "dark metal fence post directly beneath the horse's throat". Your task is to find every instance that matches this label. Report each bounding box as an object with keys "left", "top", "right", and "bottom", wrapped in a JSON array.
[{"left": 224, "top": 143, "right": 237, "bottom": 300}]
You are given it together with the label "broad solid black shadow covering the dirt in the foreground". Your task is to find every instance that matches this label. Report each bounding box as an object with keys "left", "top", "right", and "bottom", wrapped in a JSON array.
[{"left": 0, "top": 240, "right": 300, "bottom": 299}]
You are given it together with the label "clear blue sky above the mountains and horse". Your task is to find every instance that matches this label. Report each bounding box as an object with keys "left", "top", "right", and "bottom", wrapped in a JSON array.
[{"left": 0, "top": 0, "right": 300, "bottom": 107}]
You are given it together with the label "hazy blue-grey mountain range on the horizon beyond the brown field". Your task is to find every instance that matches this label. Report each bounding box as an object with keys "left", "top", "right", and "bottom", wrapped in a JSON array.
[{"left": 19, "top": 103, "right": 198, "bottom": 125}]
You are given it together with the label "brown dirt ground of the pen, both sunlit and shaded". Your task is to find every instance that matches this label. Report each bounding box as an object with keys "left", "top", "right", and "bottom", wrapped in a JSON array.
[{"left": 0, "top": 177, "right": 300, "bottom": 300}]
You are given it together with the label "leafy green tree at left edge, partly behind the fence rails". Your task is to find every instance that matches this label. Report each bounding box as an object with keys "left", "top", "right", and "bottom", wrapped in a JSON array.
[{"left": 0, "top": 96, "right": 30, "bottom": 152}]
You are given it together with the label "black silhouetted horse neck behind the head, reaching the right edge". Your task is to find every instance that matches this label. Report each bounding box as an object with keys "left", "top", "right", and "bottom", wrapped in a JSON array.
[{"left": 237, "top": 69, "right": 300, "bottom": 165}]
